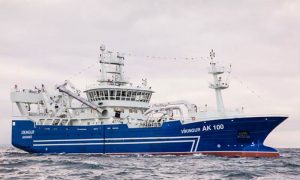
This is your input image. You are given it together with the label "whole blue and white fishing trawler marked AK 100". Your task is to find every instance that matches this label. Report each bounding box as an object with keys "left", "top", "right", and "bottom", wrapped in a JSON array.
[{"left": 11, "top": 46, "right": 287, "bottom": 157}]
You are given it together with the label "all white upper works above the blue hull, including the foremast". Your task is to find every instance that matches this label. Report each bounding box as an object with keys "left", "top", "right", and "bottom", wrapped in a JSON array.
[{"left": 11, "top": 46, "right": 243, "bottom": 127}]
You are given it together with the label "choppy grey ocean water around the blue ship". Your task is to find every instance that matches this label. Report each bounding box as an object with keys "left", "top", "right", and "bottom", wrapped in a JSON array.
[{"left": 0, "top": 147, "right": 300, "bottom": 180}]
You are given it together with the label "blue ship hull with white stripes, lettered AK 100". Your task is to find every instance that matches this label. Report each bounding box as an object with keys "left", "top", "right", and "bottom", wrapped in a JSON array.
[{"left": 12, "top": 116, "right": 287, "bottom": 157}]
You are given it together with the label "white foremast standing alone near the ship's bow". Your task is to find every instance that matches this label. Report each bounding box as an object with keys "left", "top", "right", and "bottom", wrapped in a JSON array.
[{"left": 209, "top": 50, "right": 229, "bottom": 113}]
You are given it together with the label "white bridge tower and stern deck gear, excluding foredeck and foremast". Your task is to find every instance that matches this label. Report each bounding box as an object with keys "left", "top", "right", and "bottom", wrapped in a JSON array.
[{"left": 11, "top": 46, "right": 153, "bottom": 125}]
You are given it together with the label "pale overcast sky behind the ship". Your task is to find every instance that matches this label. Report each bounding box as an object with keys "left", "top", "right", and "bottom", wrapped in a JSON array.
[{"left": 0, "top": 0, "right": 300, "bottom": 147}]
